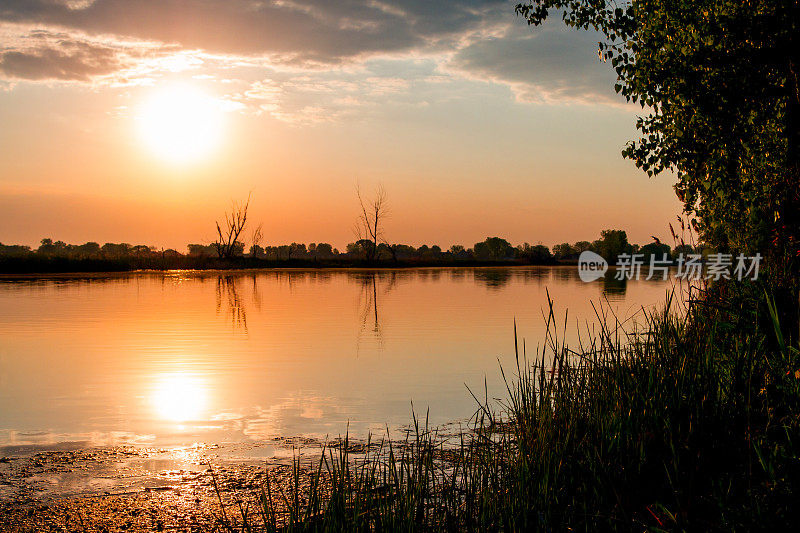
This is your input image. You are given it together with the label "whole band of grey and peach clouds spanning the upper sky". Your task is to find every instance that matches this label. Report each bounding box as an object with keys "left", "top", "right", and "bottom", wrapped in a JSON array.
[{"left": 0, "top": 0, "right": 620, "bottom": 111}]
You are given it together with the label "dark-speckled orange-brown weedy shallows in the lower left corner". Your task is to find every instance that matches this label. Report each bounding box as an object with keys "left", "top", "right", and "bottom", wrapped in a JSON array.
[{"left": 0, "top": 439, "right": 332, "bottom": 532}]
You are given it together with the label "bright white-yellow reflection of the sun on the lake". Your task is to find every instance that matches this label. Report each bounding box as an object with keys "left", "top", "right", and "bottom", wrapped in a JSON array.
[{"left": 152, "top": 373, "right": 208, "bottom": 422}]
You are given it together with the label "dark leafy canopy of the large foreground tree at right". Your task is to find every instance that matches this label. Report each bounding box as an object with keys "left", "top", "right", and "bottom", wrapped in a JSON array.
[{"left": 516, "top": 0, "right": 800, "bottom": 278}]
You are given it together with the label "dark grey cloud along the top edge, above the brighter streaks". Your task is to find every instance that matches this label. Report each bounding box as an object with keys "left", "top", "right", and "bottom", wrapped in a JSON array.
[{"left": 0, "top": 0, "right": 513, "bottom": 63}]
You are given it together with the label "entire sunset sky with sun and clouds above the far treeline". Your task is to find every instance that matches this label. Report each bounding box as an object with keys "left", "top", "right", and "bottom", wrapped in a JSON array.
[{"left": 0, "top": 0, "right": 680, "bottom": 251}]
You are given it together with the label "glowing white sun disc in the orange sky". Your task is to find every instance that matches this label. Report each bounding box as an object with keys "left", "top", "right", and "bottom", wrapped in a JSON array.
[{"left": 137, "top": 84, "right": 222, "bottom": 164}]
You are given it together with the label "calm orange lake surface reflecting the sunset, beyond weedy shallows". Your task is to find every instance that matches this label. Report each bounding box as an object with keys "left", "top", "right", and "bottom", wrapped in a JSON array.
[{"left": 0, "top": 267, "right": 672, "bottom": 446}]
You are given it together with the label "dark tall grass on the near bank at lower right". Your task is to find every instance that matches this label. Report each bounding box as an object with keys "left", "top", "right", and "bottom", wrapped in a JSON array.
[{"left": 211, "top": 282, "right": 800, "bottom": 531}]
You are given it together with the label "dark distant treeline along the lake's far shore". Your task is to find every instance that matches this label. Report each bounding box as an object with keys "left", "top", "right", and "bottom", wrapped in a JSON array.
[{"left": 0, "top": 230, "right": 697, "bottom": 272}]
